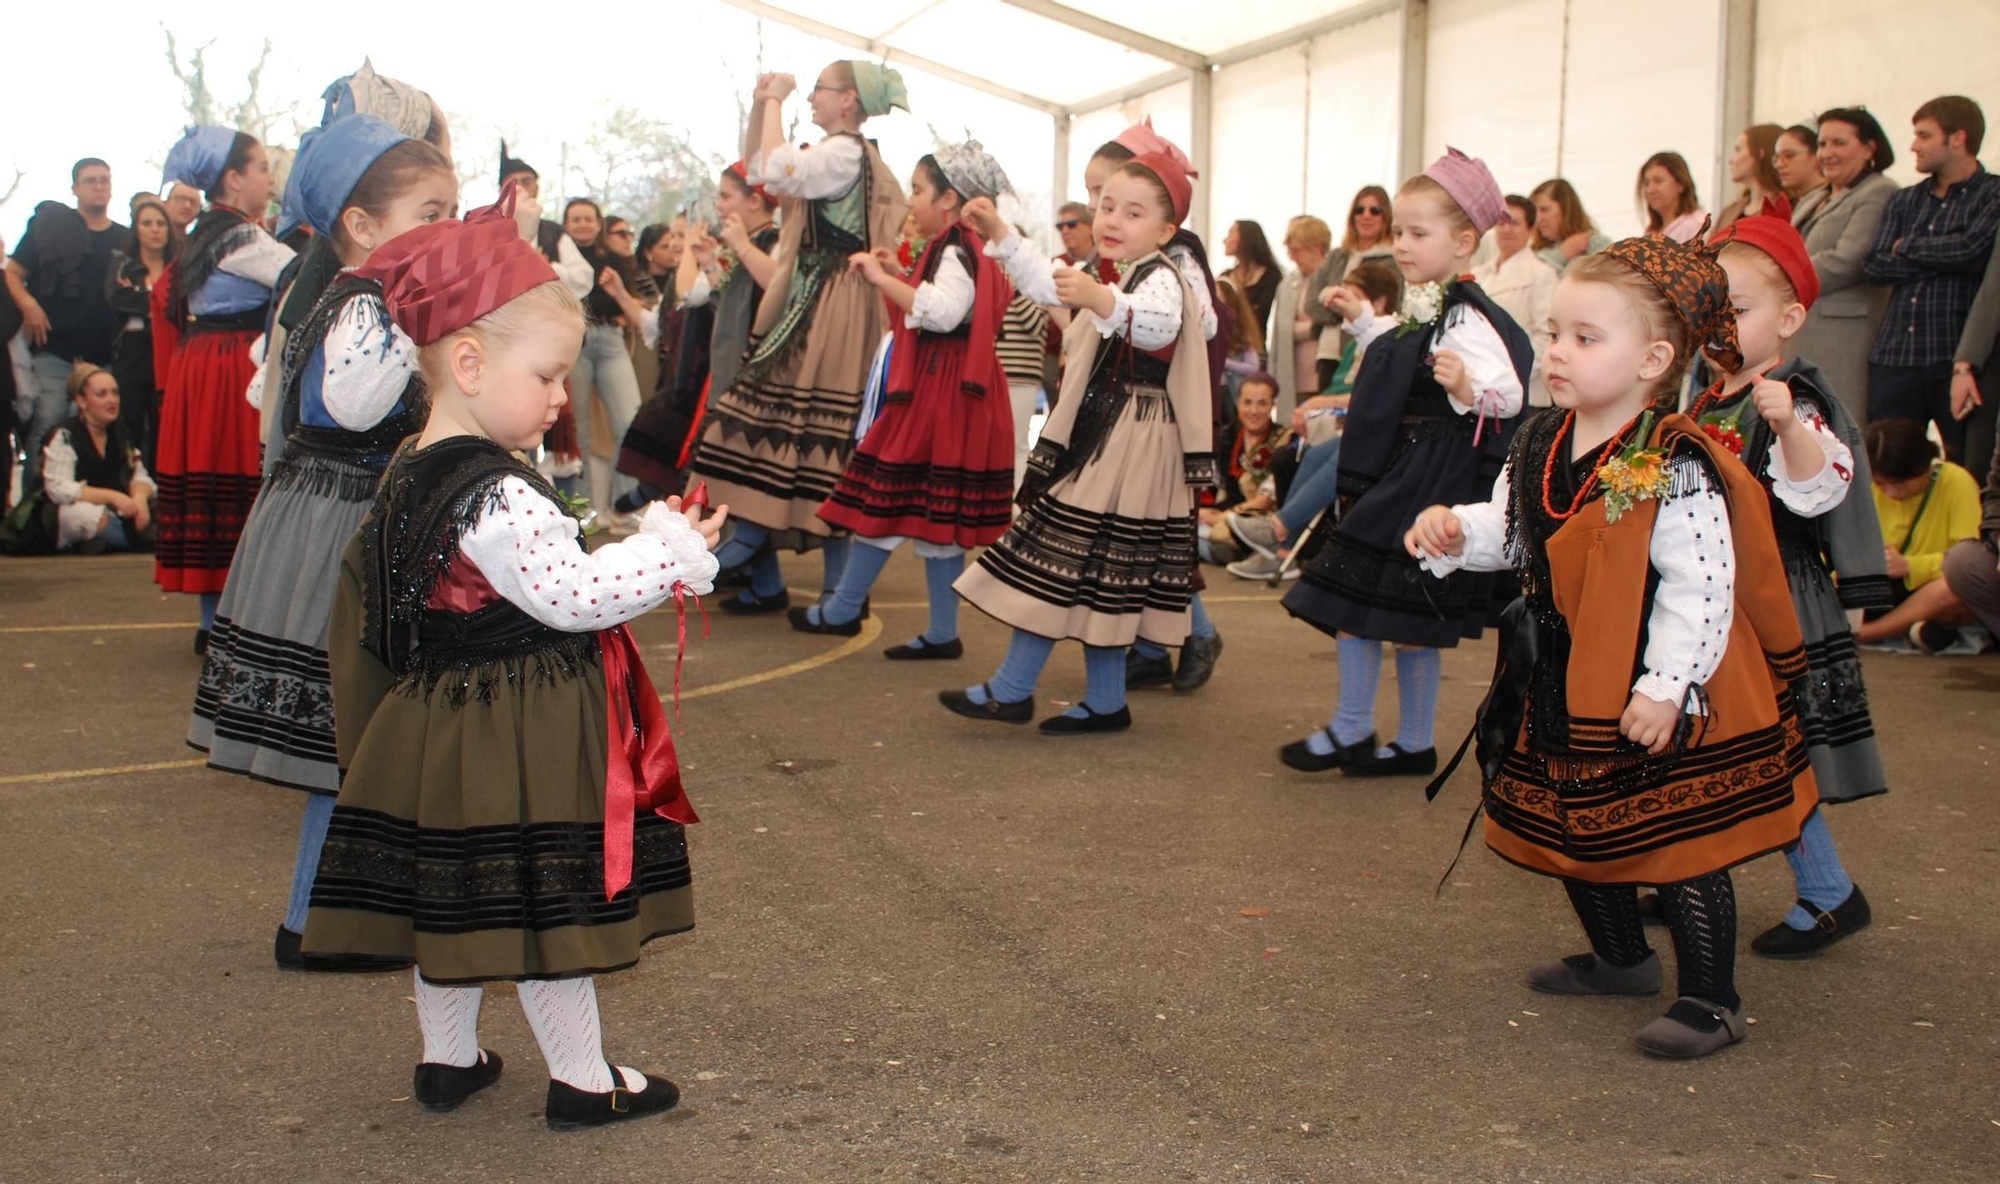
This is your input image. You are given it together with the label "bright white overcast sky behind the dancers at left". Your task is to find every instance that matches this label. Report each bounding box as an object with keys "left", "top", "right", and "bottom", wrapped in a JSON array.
[{"left": 0, "top": 0, "right": 1052, "bottom": 244}]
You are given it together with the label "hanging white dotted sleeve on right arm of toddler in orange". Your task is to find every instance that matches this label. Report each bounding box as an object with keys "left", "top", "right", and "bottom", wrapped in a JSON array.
[{"left": 1632, "top": 458, "right": 1736, "bottom": 714}]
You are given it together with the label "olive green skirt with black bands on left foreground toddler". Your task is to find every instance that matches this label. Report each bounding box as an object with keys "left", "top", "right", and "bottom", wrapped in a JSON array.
[{"left": 304, "top": 644, "right": 694, "bottom": 982}]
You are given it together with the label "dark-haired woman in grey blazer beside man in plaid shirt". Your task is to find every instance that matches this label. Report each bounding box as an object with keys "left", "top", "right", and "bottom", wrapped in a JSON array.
[{"left": 1788, "top": 108, "right": 1898, "bottom": 424}]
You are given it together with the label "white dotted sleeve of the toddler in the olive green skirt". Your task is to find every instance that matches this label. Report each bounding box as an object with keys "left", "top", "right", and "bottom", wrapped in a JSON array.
[{"left": 460, "top": 476, "right": 716, "bottom": 632}]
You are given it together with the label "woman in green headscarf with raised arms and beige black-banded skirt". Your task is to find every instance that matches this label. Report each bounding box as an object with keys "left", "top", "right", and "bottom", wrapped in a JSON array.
[{"left": 694, "top": 60, "right": 910, "bottom": 614}]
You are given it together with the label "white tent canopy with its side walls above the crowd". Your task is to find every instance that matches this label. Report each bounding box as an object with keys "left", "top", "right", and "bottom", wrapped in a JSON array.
[{"left": 724, "top": 0, "right": 2000, "bottom": 256}]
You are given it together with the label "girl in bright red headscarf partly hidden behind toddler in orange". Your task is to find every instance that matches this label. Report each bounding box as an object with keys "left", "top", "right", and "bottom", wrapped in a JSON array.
[{"left": 1688, "top": 214, "right": 1890, "bottom": 958}]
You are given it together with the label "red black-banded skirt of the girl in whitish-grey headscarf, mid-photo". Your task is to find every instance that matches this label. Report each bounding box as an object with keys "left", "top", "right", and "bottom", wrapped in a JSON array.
[{"left": 820, "top": 338, "right": 1014, "bottom": 546}]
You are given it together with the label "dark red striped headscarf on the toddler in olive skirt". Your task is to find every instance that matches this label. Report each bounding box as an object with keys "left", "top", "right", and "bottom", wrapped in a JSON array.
[{"left": 354, "top": 186, "right": 556, "bottom": 346}]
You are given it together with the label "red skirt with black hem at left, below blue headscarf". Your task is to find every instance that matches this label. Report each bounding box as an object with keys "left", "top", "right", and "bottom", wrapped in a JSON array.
[{"left": 152, "top": 330, "right": 262, "bottom": 592}]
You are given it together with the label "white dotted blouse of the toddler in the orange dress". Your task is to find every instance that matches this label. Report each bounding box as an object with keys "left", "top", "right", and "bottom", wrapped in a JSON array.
[{"left": 1418, "top": 462, "right": 1736, "bottom": 714}]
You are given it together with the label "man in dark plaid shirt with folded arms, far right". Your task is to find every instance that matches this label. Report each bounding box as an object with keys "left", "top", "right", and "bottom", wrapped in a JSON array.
[{"left": 1862, "top": 94, "right": 2000, "bottom": 462}]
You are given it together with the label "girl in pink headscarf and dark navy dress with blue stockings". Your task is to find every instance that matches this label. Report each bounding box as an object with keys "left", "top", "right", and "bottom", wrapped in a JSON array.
[{"left": 1280, "top": 148, "right": 1534, "bottom": 776}]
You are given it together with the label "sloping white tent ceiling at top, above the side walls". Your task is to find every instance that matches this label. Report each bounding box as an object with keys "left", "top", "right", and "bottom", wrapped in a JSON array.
[{"left": 726, "top": 0, "right": 1394, "bottom": 114}]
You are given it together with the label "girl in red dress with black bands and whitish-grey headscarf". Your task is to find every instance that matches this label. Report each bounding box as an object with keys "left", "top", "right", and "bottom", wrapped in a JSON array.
[{"left": 790, "top": 140, "right": 1014, "bottom": 660}]
